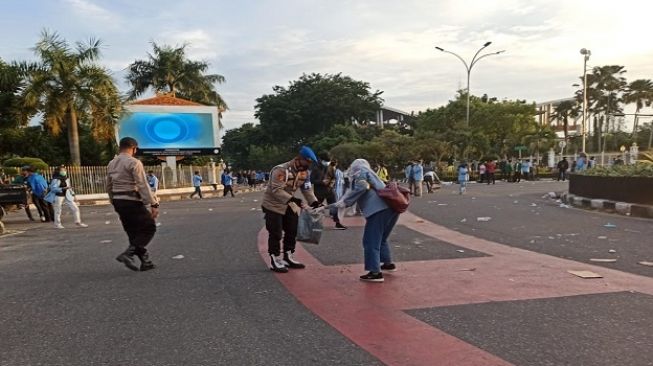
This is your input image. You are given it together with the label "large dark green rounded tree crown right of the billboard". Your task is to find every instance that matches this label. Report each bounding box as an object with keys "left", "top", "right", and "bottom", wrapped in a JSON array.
[{"left": 255, "top": 73, "right": 383, "bottom": 147}]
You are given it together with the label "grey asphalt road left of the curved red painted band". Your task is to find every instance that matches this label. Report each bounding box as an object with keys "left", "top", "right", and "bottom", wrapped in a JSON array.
[{"left": 0, "top": 194, "right": 380, "bottom": 366}]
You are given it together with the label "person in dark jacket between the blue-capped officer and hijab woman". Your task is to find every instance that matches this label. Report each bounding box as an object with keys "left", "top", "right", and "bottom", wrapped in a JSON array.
[{"left": 310, "top": 153, "right": 347, "bottom": 230}]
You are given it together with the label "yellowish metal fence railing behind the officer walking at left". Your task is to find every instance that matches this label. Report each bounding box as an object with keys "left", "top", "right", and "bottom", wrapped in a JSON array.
[{"left": 42, "top": 165, "right": 222, "bottom": 194}]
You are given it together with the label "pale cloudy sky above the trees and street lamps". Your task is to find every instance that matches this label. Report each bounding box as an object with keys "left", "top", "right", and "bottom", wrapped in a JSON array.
[{"left": 0, "top": 0, "right": 653, "bottom": 129}]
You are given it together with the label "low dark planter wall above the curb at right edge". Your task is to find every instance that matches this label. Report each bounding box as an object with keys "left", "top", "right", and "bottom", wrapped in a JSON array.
[{"left": 569, "top": 174, "right": 653, "bottom": 205}]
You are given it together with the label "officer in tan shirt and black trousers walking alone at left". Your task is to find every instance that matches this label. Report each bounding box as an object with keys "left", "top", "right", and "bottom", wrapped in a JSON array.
[{"left": 106, "top": 137, "right": 159, "bottom": 271}]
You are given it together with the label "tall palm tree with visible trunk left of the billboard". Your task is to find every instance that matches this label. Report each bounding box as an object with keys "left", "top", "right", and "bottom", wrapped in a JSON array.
[{"left": 22, "top": 31, "right": 122, "bottom": 165}]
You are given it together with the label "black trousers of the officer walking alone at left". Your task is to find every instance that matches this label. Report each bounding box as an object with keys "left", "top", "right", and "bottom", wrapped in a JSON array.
[{"left": 111, "top": 200, "right": 156, "bottom": 256}]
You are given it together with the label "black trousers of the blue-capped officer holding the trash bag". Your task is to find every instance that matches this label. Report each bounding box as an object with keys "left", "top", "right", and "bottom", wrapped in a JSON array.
[{"left": 263, "top": 207, "right": 299, "bottom": 255}]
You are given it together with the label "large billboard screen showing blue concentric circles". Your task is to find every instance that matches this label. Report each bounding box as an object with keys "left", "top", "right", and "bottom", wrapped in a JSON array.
[{"left": 117, "top": 105, "right": 220, "bottom": 156}]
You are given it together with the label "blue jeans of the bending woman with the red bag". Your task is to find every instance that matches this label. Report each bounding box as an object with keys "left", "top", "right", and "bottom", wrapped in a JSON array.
[{"left": 363, "top": 208, "right": 399, "bottom": 273}]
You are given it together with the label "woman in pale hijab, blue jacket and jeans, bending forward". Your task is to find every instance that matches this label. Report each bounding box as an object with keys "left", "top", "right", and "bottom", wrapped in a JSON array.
[{"left": 334, "top": 159, "right": 399, "bottom": 282}]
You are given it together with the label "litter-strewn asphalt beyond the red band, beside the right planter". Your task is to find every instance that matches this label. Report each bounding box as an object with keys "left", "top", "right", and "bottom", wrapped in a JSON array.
[{"left": 410, "top": 181, "right": 653, "bottom": 277}]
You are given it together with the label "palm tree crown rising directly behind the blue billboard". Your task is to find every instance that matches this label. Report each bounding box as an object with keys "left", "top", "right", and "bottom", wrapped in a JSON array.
[{"left": 127, "top": 42, "right": 227, "bottom": 110}]
